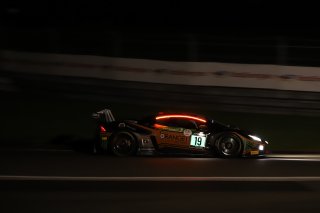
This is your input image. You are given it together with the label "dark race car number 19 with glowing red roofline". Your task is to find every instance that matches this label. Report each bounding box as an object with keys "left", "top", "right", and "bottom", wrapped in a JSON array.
[{"left": 93, "top": 109, "right": 268, "bottom": 158}]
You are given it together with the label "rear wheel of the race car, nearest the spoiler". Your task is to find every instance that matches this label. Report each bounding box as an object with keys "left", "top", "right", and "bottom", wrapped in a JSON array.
[{"left": 111, "top": 132, "right": 138, "bottom": 157}]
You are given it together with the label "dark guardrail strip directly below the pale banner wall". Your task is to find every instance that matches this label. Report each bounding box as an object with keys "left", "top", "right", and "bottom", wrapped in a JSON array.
[{"left": 0, "top": 72, "right": 320, "bottom": 116}]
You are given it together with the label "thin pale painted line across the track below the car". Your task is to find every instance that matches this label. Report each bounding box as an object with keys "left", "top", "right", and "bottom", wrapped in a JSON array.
[{"left": 0, "top": 175, "right": 320, "bottom": 182}]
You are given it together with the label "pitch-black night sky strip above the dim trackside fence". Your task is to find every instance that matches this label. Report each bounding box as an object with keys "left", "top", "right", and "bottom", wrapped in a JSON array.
[{"left": 1, "top": 0, "right": 320, "bottom": 36}]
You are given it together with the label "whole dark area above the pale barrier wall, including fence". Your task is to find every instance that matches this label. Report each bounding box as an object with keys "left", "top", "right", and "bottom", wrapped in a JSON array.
[{"left": 0, "top": 1, "right": 320, "bottom": 66}]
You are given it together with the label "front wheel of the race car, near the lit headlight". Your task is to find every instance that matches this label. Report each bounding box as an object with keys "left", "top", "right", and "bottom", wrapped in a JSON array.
[{"left": 215, "top": 133, "right": 243, "bottom": 158}]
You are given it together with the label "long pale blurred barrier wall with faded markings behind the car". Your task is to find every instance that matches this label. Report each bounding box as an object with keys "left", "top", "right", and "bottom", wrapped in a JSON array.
[{"left": 0, "top": 51, "right": 320, "bottom": 92}]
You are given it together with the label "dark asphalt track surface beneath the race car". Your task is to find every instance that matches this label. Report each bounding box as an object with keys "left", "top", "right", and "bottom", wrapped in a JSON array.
[{"left": 0, "top": 150, "right": 320, "bottom": 212}]
